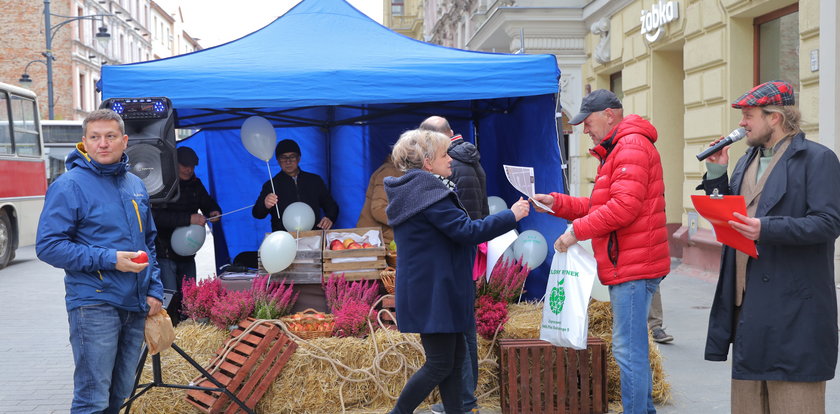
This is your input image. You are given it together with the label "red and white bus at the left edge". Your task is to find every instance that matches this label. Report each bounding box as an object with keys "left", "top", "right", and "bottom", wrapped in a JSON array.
[{"left": 0, "top": 83, "right": 47, "bottom": 268}]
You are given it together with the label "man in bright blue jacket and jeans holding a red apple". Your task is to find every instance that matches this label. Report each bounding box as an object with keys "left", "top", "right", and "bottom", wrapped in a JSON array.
[{"left": 36, "top": 109, "right": 163, "bottom": 413}]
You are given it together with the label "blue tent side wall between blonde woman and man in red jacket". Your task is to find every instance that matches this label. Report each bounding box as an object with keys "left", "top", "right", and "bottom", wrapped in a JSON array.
[{"left": 478, "top": 95, "right": 566, "bottom": 299}]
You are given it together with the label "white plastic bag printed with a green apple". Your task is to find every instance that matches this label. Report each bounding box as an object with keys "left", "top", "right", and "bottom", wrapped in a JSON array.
[{"left": 540, "top": 244, "right": 598, "bottom": 349}]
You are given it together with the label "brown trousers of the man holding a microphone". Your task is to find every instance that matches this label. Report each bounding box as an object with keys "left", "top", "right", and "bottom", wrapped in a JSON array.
[{"left": 731, "top": 379, "right": 825, "bottom": 414}]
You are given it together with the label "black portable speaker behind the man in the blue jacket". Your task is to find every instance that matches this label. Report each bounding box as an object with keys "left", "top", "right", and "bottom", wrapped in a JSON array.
[{"left": 100, "top": 97, "right": 179, "bottom": 204}]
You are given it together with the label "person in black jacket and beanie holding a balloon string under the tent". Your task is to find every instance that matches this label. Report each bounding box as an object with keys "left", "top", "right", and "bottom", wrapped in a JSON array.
[{"left": 251, "top": 139, "right": 338, "bottom": 231}]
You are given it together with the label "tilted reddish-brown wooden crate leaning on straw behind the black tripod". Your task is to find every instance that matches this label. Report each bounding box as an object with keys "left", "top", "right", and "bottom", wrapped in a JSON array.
[{"left": 186, "top": 319, "right": 297, "bottom": 413}]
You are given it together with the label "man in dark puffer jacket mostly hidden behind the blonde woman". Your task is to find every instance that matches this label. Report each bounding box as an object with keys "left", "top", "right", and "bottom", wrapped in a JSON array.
[{"left": 420, "top": 116, "right": 490, "bottom": 414}]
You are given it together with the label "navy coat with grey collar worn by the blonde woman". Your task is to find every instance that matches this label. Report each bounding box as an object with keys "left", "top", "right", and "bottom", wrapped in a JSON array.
[{"left": 385, "top": 170, "right": 516, "bottom": 333}]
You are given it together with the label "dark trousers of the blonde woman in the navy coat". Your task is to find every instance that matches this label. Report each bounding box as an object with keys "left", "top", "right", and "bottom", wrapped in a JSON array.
[{"left": 391, "top": 332, "right": 466, "bottom": 414}]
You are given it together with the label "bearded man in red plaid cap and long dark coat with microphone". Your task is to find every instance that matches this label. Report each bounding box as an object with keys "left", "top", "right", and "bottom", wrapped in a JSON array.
[{"left": 697, "top": 81, "right": 840, "bottom": 414}]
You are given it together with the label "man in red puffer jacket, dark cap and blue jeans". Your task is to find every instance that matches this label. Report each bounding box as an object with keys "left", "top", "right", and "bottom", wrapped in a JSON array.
[{"left": 534, "top": 89, "right": 671, "bottom": 414}]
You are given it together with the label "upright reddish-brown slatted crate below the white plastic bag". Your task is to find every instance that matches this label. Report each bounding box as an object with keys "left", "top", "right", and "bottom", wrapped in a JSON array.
[{"left": 499, "top": 337, "right": 609, "bottom": 414}]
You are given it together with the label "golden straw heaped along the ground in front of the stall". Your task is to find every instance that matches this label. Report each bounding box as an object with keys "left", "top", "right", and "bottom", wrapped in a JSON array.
[{"left": 132, "top": 300, "right": 670, "bottom": 414}]
